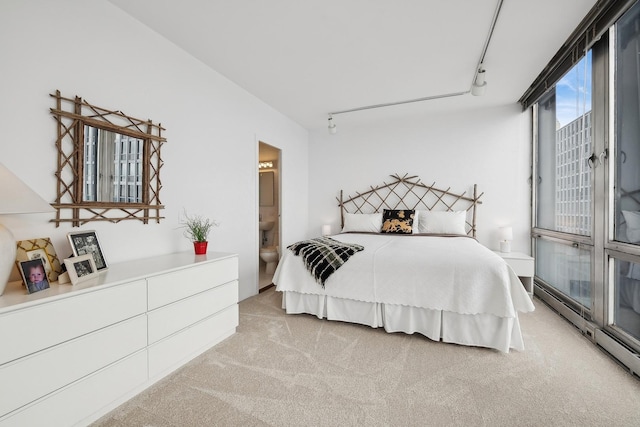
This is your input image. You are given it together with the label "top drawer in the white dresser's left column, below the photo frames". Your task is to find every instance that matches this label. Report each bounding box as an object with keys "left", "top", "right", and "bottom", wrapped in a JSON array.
[{"left": 0, "top": 280, "right": 147, "bottom": 365}]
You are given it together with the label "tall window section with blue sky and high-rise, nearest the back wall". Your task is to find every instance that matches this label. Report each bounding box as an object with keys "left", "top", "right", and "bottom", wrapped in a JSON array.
[{"left": 535, "top": 52, "right": 592, "bottom": 311}]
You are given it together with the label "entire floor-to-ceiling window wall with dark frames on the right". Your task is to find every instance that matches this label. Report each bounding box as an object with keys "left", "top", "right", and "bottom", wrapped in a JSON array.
[{"left": 521, "top": 0, "right": 640, "bottom": 373}]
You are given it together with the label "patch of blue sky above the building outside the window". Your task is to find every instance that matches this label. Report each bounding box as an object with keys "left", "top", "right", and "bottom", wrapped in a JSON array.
[{"left": 556, "top": 51, "right": 591, "bottom": 126}]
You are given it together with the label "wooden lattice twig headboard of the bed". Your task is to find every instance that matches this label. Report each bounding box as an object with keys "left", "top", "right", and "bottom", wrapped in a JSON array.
[{"left": 338, "top": 174, "right": 484, "bottom": 241}]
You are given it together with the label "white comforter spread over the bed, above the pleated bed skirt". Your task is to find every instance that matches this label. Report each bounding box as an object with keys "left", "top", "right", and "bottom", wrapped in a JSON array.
[{"left": 273, "top": 233, "right": 534, "bottom": 318}]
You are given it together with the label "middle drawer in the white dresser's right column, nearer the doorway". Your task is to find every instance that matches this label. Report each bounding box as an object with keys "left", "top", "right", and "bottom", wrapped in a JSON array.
[{"left": 148, "top": 280, "right": 238, "bottom": 344}]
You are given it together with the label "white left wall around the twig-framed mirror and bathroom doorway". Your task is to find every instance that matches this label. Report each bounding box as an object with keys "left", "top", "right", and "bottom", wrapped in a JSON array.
[{"left": 0, "top": 0, "right": 308, "bottom": 299}]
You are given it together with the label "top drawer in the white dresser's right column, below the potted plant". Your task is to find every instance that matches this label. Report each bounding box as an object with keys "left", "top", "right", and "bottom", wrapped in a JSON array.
[{"left": 147, "top": 257, "right": 238, "bottom": 310}]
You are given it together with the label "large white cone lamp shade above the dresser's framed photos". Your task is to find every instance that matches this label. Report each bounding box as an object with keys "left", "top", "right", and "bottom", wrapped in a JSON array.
[{"left": 0, "top": 163, "right": 54, "bottom": 215}]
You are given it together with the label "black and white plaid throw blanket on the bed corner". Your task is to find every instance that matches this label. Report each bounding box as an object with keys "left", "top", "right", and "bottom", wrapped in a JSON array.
[{"left": 287, "top": 237, "right": 364, "bottom": 288}]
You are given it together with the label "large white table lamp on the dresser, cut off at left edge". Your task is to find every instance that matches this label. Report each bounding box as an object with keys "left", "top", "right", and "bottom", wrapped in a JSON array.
[{"left": 0, "top": 163, "right": 55, "bottom": 295}]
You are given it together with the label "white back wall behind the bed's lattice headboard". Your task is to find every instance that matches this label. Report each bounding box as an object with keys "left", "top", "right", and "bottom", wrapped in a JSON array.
[{"left": 309, "top": 101, "right": 531, "bottom": 253}]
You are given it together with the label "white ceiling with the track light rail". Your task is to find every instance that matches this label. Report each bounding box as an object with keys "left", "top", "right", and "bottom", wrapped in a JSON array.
[{"left": 109, "top": 0, "right": 596, "bottom": 130}]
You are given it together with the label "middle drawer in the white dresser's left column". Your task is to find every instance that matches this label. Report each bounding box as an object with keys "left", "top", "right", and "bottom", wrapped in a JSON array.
[{"left": 0, "top": 315, "right": 147, "bottom": 416}]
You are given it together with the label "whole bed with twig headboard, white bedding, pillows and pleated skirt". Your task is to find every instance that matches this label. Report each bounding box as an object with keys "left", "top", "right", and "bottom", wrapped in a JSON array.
[{"left": 273, "top": 174, "right": 534, "bottom": 353}]
